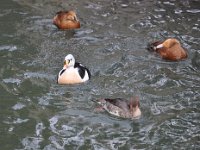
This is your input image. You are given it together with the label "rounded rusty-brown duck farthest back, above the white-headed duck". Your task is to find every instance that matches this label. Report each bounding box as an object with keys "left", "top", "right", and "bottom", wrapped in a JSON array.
[{"left": 53, "top": 10, "right": 80, "bottom": 29}]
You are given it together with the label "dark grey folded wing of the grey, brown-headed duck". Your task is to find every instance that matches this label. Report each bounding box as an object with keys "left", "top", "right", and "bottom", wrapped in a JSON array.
[{"left": 105, "top": 98, "right": 130, "bottom": 111}]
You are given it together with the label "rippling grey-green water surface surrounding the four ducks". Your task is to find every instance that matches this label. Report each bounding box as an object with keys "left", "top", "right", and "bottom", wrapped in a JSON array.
[{"left": 0, "top": 0, "right": 200, "bottom": 149}]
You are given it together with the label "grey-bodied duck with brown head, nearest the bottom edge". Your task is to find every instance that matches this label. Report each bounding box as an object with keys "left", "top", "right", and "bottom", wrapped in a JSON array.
[{"left": 95, "top": 98, "right": 141, "bottom": 119}]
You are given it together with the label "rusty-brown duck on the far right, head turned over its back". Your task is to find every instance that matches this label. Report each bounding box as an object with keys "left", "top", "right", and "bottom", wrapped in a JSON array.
[{"left": 148, "top": 38, "right": 187, "bottom": 61}]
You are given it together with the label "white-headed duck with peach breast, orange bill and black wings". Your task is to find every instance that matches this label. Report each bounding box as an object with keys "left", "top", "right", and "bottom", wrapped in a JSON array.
[{"left": 57, "top": 54, "right": 91, "bottom": 84}]
